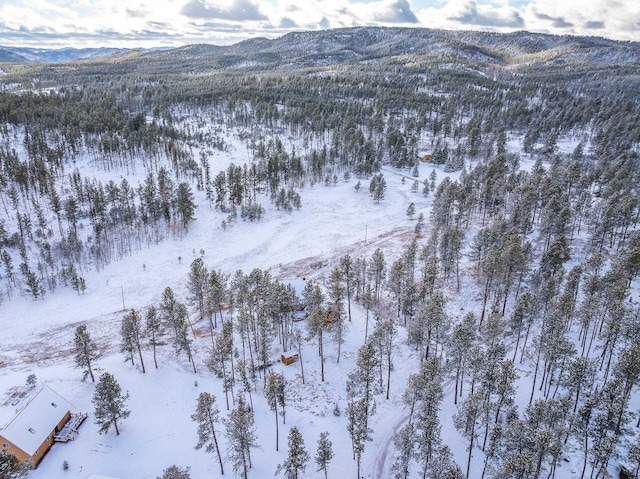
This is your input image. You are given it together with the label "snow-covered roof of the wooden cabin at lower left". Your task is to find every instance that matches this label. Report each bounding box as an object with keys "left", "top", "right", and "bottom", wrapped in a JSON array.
[{"left": 0, "top": 386, "right": 71, "bottom": 455}]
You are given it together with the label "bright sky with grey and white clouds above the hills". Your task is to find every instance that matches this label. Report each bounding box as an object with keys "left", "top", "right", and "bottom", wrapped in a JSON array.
[{"left": 0, "top": 0, "right": 640, "bottom": 48}]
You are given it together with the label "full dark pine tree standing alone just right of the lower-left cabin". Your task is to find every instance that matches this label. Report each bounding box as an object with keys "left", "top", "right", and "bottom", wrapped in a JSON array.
[{"left": 91, "top": 372, "right": 130, "bottom": 435}]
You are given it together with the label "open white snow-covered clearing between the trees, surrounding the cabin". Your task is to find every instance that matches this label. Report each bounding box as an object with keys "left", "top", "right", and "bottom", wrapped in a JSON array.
[{"left": 0, "top": 127, "right": 632, "bottom": 479}]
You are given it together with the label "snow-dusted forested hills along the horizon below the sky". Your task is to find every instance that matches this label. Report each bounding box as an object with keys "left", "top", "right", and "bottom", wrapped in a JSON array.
[{"left": 0, "top": 27, "right": 640, "bottom": 72}]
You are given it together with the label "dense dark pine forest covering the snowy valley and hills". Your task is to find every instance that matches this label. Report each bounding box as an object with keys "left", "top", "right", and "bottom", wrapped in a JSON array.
[{"left": 0, "top": 28, "right": 640, "bottom": 479}]
